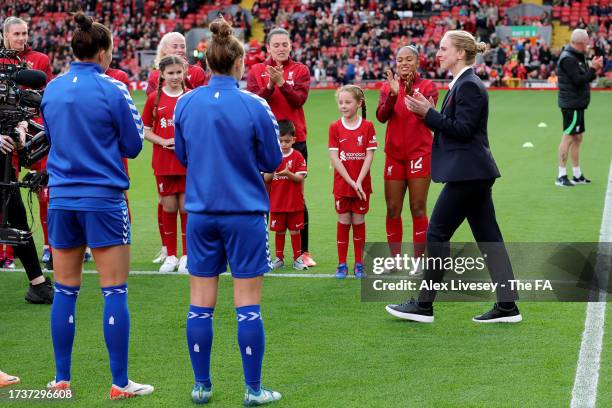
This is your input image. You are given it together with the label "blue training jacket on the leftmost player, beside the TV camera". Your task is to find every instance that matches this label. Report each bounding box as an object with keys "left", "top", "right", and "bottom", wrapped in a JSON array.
[{"left": 41, "top": 62, "right": 144, "bottom": 198}]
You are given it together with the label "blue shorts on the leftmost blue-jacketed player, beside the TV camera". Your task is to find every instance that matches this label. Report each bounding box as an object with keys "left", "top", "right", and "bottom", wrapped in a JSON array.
[{"left": 47, "top": 201, "right": 132, "bottom": 249}]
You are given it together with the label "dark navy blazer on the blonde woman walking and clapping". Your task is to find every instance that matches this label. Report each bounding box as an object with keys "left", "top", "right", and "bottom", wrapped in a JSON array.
[{"left": 425, "top": 68, "right": 500, "bottom": 183}]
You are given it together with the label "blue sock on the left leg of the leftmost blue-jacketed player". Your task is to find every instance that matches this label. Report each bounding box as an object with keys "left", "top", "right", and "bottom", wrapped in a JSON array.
[{"left": 51, "top": 282, "right": 81, "bottom": 381}]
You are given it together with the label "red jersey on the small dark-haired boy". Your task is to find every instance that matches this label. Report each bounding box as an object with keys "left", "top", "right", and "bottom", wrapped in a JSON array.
[{"left": 270, "top": 149, "right": 307, "bottom": 212}]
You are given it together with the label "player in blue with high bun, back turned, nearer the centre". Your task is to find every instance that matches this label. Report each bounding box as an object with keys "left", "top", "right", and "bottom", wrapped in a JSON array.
[{"left": 174, "top": 18, "right": 282, "bottom": 406}]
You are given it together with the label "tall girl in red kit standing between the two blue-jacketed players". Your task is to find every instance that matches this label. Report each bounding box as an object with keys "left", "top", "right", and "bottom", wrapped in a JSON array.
[{"left": 142, "top": 55, "right": 187, "bottom": 273}]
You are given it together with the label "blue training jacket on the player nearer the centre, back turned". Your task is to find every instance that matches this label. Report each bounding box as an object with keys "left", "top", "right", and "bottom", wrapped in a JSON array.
[{"left": 174, "top": 75, "right": 282, "bottom": 214}]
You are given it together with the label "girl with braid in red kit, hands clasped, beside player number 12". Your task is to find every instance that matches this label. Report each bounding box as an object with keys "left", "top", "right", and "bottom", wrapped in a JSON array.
[{"left": 328, "top": 85, "right": 378, "bottom": 279}]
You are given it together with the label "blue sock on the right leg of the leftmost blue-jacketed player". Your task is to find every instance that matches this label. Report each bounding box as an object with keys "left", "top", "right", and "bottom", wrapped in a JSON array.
[{"left": 102, "top": 283, "right": 130, "bottom": 387}]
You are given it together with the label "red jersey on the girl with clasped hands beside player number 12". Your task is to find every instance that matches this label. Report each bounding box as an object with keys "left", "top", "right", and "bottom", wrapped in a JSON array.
[{"left": 328, "top": 118, "right": 378, "bottom": 197}]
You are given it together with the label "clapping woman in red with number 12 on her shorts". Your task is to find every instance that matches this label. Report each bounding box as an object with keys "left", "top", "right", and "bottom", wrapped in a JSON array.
[{"left": 376, "top": 45, "right": 438, "bottom": 270}]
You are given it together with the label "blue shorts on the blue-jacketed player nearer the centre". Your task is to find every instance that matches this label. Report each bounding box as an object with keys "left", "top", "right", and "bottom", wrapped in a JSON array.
[{"left": 187, "top": 213, "right": 272, "bottom": 279}]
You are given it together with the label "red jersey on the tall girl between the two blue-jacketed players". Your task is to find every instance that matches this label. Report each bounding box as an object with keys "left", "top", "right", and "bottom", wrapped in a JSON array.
[{"left": 142, "top": 90, "right": 186, "bottom": 176}]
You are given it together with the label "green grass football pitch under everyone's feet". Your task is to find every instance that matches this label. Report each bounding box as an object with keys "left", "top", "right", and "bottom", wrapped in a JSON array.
[{"left": 0, "top": 91, "right": 612, "bottom": 408}]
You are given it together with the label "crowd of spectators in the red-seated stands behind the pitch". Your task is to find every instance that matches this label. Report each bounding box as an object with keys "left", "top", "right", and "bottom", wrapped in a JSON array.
[{"left": 0, "top": 0, "right": 612, "bottom": 84}]
